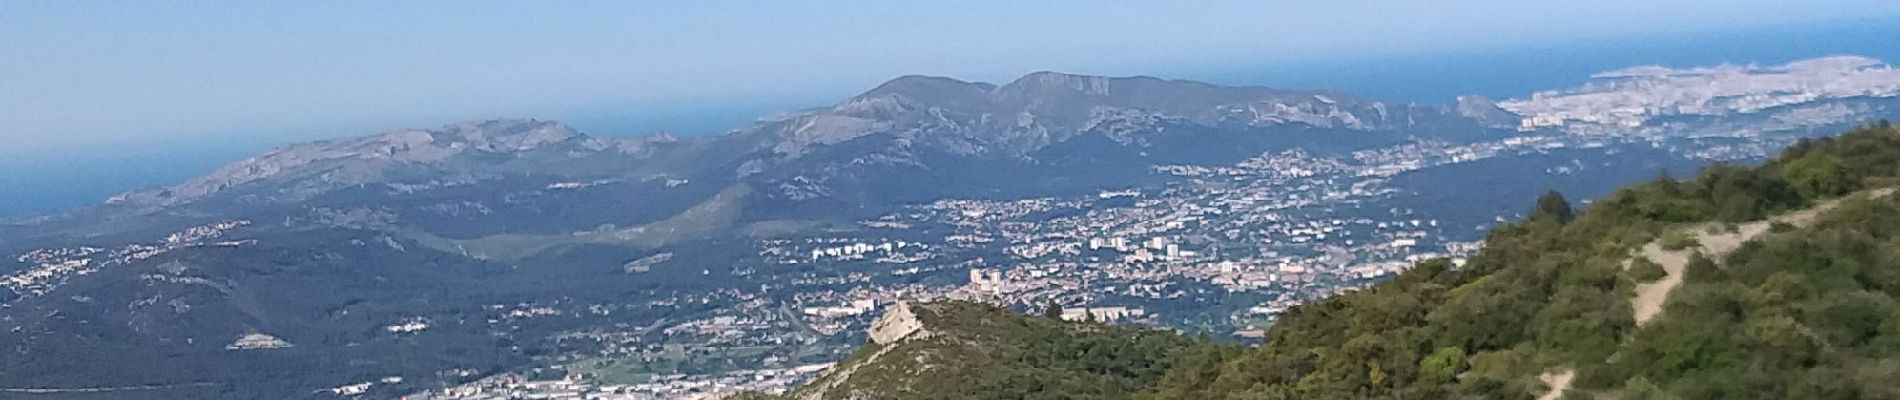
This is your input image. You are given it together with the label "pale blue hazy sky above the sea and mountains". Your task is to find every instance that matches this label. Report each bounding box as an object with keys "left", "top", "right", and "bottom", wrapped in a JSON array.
[{"left": 11, "top": 0, "right": 1900, "bottom": 155}]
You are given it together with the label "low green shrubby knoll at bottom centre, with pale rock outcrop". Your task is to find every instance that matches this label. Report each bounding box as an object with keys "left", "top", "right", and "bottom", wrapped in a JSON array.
[{"left": 775, "top": 301, "right": 1235, "bottom": 400}]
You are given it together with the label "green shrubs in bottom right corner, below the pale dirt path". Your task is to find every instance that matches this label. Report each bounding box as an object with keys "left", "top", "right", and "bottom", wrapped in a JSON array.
[{"left": 1581, "top": 188, "right": 1900, "bottom": 398}]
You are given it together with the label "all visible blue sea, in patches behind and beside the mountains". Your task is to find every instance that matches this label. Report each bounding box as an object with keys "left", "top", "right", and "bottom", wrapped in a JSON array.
[{"left": 0, "top": 21, "right": 1900, "bottom": 218}]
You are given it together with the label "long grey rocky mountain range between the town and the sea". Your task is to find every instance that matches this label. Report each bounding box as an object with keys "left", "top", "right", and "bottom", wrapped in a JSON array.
[{"left": 52, "top": 72, "right": 1497, "bottom": 233}]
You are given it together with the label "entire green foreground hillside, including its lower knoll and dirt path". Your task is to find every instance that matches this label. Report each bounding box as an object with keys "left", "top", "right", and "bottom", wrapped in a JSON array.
[{"left": 779, "top": 123, "right": 1900, "bottom": 400}]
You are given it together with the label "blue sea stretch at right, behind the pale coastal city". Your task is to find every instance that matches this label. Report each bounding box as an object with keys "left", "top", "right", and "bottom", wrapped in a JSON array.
[{"left": 1182, "top": 21, "right": 1900, "bottom": 104}]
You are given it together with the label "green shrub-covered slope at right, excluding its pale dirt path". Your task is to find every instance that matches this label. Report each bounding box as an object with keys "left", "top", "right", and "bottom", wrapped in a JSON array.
[{"left": 1140, "top": 123, "right": 1900, "bottom": 398}]
